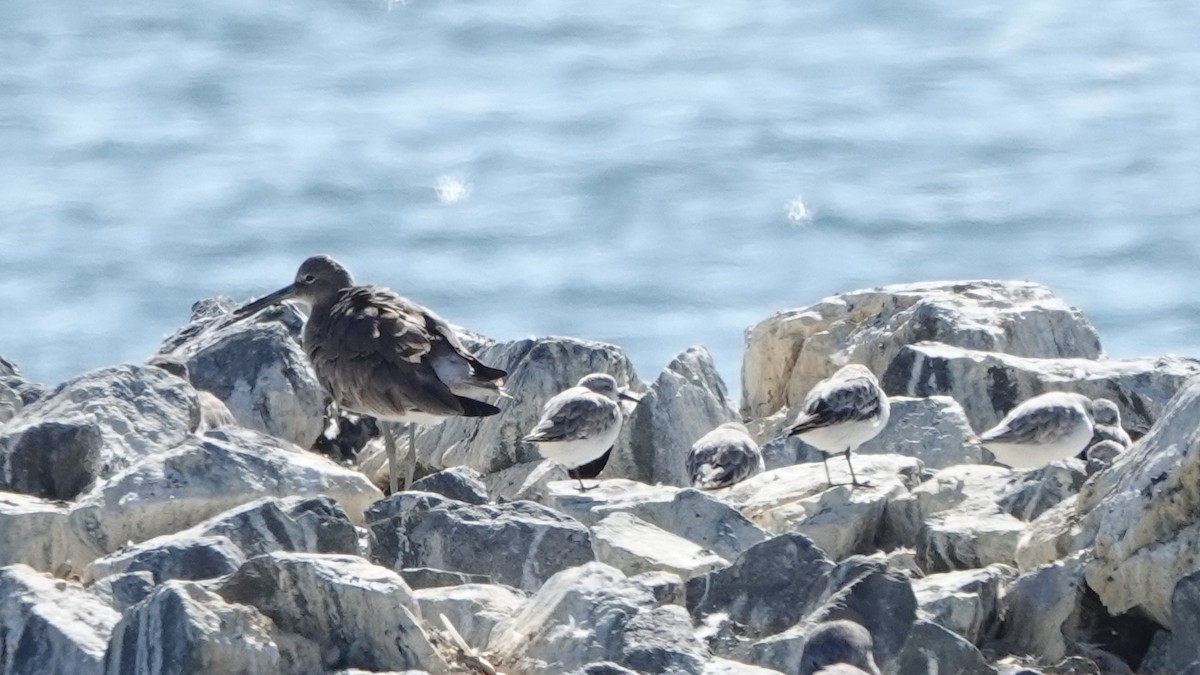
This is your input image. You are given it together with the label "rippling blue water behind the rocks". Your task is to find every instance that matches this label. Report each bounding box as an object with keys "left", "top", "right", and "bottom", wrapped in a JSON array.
[{"left": 0, "top": 0, "right": 1200, "bottom": 388}]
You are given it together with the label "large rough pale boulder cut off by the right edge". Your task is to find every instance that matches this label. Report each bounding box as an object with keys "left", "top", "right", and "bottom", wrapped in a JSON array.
[{"left": 1068, "top": 381, "right": 1200, "bottom": 627}]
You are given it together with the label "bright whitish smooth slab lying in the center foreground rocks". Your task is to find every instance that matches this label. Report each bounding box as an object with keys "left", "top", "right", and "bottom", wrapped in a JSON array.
[{"left": 592, "top": 512, "right": 728, "bottom": 579}]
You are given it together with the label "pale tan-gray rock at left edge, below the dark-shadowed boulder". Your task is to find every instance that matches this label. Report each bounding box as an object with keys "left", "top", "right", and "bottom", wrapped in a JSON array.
[{"left": 0, "top": 492, "right": 95, "bottom": 573}]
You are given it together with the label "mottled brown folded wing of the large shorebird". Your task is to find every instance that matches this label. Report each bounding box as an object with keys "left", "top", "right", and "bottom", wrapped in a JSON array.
[{"left": 305, "top": 286, "right": 498, "bottom": 418}]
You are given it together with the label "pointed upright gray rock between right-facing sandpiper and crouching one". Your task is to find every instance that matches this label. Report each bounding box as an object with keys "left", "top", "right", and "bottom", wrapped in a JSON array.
[{"left": 606, "top": 347, "right": 737, "bottom": 486}]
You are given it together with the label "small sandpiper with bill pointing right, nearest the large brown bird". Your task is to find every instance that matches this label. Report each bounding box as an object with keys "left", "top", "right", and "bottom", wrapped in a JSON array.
[{"left": 524, "top": 372, "right": 641, "bottom": 491}]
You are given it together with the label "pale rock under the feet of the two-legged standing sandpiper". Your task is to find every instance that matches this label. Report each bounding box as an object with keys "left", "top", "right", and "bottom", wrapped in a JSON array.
[{"left": 713, "top": 455, "right": 920, "bottom": 560}]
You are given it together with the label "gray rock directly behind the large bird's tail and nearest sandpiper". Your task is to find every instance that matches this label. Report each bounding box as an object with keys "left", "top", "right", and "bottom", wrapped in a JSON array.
[{"left": 405, "top": 338, "right": 642, "bottom": 474}]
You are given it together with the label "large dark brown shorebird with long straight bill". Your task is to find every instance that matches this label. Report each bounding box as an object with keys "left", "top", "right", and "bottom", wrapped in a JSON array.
[{"left": 234, "top": 256, "right": 506, "bottom": 492}]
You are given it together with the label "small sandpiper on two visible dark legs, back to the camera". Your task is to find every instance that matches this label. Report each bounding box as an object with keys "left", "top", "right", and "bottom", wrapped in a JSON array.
[{"left": 787, "top": 364, "right": 892, "bottom": 486}]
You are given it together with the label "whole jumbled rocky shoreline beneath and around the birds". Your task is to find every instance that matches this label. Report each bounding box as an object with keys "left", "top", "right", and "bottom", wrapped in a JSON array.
[{"left": 0, "top": 281, "right": 1200, "bottom": 675}]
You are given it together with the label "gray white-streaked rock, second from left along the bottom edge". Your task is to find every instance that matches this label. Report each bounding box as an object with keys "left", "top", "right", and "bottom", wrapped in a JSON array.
[{"left": 103, "top": 581, "right": 304, "bottom": 675}]
